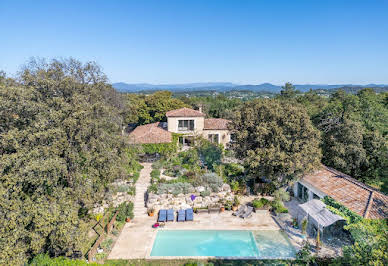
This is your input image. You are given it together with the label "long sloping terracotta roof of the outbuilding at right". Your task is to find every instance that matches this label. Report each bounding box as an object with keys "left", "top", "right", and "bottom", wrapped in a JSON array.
[{"left": 302, "top": 166, "right": 388, "bottom": 219}]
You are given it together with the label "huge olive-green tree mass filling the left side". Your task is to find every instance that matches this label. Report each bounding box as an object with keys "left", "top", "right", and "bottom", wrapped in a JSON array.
[{"left": 0, "top": 59, "right": 128, "bottom": 265}]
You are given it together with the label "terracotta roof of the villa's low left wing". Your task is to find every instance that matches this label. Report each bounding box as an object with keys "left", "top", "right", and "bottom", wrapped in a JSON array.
[{"left": 128, "top": 122, "right": 172, "bottom": 144}]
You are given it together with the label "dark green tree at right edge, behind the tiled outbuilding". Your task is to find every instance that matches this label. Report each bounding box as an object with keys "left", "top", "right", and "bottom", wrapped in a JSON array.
[{"left": 314, "top": 89, "right": 388, "bottom": 189}]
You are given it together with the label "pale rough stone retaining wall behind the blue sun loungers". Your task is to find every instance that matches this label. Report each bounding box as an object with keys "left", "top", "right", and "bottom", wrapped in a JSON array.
[{"left": 147, "top": 184, "right": 234, "bottom": 212}]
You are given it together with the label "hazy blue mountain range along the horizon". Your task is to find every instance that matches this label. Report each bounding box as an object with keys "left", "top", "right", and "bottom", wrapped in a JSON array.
[{"left": 112, "top": 82, "right": 388, "bottom": 93}]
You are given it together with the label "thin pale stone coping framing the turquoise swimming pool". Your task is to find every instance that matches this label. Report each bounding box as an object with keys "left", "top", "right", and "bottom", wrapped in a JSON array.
[{"left": 145, "top": 228, "right": 296, "bottom": 260}]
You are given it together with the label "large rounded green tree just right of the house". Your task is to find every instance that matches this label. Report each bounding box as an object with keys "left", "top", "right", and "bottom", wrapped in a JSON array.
[{"left": 231, "top": 100, "right": 321, "bottom": 190}]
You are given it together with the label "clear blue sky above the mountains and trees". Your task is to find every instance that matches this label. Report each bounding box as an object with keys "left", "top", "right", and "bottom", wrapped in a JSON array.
[{"left": 0, "top": 0, "right": 388, "bottom": 84}]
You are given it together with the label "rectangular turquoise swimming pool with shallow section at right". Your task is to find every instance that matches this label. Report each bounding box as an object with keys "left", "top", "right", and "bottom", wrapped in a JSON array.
[{"left": 150, "top": 230, "right": 295, "bottom": 259}]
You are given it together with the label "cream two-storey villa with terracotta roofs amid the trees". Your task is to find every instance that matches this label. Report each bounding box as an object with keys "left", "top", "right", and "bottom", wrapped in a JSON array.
[{"left": 129, "top": 108, "right": 231, "bottom": 147}]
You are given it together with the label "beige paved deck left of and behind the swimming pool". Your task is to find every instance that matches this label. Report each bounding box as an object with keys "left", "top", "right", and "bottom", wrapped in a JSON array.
[{"left": 108, "top": 211, "right": 280, "bottom": 259}]
